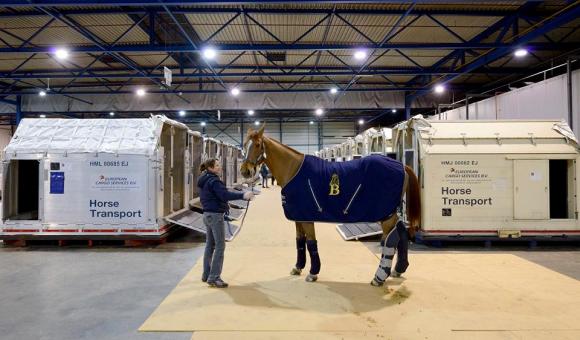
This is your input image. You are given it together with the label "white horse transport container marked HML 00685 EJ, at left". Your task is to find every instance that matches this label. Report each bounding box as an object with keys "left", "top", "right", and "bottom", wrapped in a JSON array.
[{"left": 0, "top": 116, "right": 199, "bottom": 239}]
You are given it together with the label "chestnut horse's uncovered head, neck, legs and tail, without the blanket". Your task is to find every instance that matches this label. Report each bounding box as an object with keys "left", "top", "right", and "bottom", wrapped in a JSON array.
[{"left": 240, "top": 126, "right": 421, "bottom": 286}]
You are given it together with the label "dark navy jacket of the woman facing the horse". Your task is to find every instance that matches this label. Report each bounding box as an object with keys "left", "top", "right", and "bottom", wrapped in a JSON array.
[{"left": 197, "top": 171, "right": 244, "bottom": 213}]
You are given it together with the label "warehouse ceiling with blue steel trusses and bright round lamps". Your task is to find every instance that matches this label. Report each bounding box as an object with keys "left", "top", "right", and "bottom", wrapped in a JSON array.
[{"left": 0, "top": 0, "right": 580, "bottom": 122}]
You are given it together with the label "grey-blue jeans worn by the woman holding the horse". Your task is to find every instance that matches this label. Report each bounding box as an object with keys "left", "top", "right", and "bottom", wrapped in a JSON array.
[{"left": 203, "top": 212, "right": 226, "bottom": 282}]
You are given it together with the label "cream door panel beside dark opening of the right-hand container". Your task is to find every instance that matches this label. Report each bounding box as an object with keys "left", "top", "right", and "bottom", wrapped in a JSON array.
[{"left": 514, "top": 160, "right": 550, "bottom": 220}]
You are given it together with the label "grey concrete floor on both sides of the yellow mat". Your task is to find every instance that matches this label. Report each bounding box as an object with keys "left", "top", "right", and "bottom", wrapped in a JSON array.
[{"left": 0, "top": 226, "right": 580, "bottom": 340}]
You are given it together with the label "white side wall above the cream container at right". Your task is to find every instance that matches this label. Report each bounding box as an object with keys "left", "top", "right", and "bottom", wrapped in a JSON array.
[{"left": 440, "top": 70, "right": 580, "bottom": 137}]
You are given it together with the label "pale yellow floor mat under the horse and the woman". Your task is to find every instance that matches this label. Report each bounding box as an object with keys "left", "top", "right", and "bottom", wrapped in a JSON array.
[{"left": 140, "top": 188, "right": 580, "bottom": 340}]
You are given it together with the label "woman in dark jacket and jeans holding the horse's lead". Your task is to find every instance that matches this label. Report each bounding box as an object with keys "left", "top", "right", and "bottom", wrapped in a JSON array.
[{"left": 197, "top": 159, "right": 254, "bottom": 288}]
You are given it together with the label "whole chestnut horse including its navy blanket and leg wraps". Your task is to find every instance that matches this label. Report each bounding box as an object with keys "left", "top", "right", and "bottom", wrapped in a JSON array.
[{"left": 240, "top": 126, "right": 421, "bottom": 286}]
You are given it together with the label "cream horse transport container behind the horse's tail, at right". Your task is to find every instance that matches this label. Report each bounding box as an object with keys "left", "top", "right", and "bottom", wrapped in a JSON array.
[{"left": 394, "top": 116, "right": 580, "bottom": 239}]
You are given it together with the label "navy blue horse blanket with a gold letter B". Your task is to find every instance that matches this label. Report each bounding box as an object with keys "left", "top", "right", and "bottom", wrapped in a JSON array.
[{"left": 282, "top": 155, "right": 405, "bottom": 223}]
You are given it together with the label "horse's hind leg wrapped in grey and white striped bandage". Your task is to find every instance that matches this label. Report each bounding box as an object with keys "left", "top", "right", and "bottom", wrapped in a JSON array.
[{"left": 371, "top": 213, "right": 399, "bottom": 287}]
